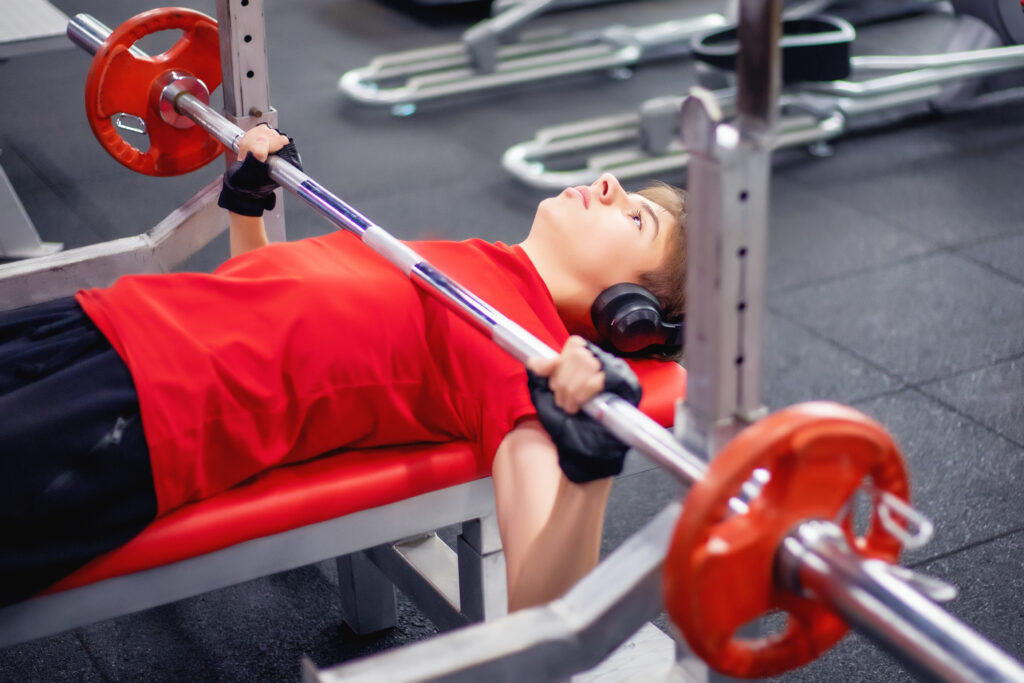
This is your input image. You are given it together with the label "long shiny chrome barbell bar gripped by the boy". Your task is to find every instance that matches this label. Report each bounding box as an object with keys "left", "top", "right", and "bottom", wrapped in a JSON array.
[{"left": 68, "top": 15, "right": 1024, "bottom": 681}]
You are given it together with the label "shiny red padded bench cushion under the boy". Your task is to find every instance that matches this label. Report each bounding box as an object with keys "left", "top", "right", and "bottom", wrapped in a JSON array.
[{"left": 46, "top": 361, "right": 686, "bottom": 593}]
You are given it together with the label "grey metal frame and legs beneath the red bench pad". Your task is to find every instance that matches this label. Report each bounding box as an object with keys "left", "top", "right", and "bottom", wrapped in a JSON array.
[{"left": 0, "top": 475, "right": 506, "bottom": 647}]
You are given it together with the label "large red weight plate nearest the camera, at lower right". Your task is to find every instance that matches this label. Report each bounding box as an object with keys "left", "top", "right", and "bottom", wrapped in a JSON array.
[{"left": 664, "top": 402, "right": 909, "bottom": 678}]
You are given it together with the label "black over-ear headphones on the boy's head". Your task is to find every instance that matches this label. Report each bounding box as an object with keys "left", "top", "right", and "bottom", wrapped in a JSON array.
[{"left": 590, "top": 283, "right": 684, "bottom": 355}]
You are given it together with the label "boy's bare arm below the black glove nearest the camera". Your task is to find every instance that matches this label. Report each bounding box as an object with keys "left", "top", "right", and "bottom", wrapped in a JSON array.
[{"left": 493, "top": 421, "right": 611, "bottom": 611}]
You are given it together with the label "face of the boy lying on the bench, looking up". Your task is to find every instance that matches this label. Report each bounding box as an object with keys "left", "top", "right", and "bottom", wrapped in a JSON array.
[{"left": 532, "top": 173, "right": 677, "bottom": 296}]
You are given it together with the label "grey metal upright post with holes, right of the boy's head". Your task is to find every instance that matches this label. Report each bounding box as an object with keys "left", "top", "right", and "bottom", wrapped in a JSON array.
[{"left": 676, "top": 0, "right": 782, "bottom": 681}]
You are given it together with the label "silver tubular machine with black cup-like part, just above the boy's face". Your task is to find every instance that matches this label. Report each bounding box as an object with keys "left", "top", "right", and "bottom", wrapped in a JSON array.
[{"left": 502, "top": 0, "right": 1024, "bottom": 189}]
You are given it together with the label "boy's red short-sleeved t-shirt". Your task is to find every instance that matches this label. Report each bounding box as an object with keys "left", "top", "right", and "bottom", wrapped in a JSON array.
[{"left": 78, "top": 232, "right": 568, "bottom": 513}]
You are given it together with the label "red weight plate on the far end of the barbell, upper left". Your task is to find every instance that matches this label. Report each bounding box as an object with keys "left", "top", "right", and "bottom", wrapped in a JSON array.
[{"left": 85, "top": 7, "right": 222, "bottom": 176}]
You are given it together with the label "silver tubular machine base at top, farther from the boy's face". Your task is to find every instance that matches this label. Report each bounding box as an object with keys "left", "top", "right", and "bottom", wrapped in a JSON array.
[{"left": 338, "top": 0, "right": 936, "bottom": 116}]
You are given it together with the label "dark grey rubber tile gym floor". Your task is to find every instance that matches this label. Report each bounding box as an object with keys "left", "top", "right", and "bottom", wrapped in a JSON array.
[{"left": 0, "top": 0, "right": 1024, "bottom": 681}]
